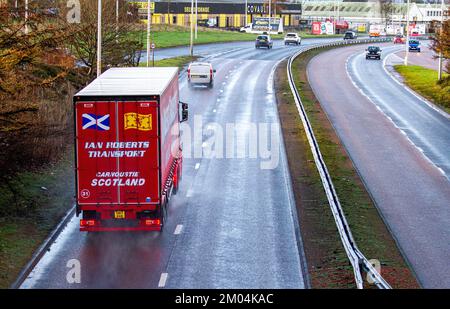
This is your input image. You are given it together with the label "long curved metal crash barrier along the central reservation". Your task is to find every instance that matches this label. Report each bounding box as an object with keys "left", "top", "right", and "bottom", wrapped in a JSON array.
[{"left": 287, "top": 38, "right": 391, "bottom": 289}]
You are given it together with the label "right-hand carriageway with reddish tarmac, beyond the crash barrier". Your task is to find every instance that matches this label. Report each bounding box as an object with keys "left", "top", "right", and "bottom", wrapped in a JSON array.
[{"left": 308, "top": 44, "right": 450, "bottom": 288}]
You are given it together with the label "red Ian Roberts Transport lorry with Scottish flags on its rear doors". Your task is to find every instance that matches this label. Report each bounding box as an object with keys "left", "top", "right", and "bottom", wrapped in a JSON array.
[{"left": 74, "top": 68, "right": 188, "bottom": 232}]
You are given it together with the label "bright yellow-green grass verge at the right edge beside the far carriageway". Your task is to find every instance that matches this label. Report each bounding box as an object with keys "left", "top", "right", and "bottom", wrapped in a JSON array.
[{"left": 394, "top": 65, "right": 450, "bottom": 113}]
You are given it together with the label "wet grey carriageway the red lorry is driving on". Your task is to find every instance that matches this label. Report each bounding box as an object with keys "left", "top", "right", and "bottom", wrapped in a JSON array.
[{"left": 21, "top": 40, "right": 342, "bottom": 288}]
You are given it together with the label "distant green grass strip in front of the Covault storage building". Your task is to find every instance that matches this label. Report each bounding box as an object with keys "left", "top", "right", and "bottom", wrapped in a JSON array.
[{"left": 131, "top": 25, "right": 342, "bottom": 48}]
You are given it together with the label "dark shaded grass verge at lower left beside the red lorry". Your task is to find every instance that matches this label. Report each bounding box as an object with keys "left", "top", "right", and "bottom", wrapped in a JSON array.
[{"left": 0, "top": 150, "right": 74, "bottom": 288}]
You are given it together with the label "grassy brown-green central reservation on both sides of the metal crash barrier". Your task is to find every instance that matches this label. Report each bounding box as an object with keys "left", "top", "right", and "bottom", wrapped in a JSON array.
[{"left": 276, "top": 50, "right": 419, "bottom": 288}]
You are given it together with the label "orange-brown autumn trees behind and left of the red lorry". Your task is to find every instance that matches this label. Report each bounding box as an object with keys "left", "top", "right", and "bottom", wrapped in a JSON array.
[{"left": 0, "top": 0, "right": 142, "bottom": 184}]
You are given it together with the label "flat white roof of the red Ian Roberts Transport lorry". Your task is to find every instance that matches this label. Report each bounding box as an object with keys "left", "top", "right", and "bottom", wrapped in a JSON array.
[{"left": 75, "top": 67, "right": 178, "bottom": 96}]
